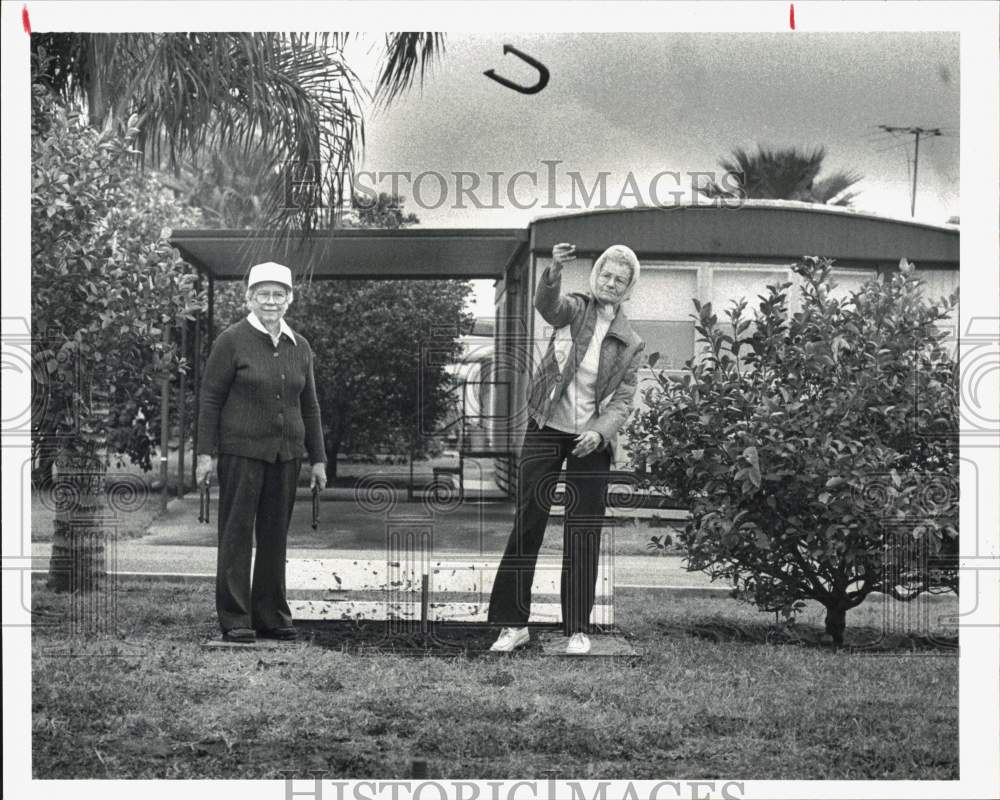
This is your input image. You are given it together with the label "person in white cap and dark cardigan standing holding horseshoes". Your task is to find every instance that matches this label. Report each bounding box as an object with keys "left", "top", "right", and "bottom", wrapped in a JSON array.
[{"left": 196, "top": 262, "right": 326, "bottom": 642}]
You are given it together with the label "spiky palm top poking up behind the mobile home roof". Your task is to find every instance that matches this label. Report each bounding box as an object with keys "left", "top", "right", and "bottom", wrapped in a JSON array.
[{"left": 699, "top": 146, "right": 863, "bottom": 206}]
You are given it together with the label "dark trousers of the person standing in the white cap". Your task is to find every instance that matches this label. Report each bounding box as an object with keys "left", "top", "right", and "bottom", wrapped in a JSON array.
[{"left": 215, "top": 454, "right": 301, "bottom": 631}]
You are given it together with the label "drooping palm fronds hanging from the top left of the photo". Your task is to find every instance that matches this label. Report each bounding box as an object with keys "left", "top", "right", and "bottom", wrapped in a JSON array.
[{"left": 31, "top": 32, "right": 444, "bottom": 231}]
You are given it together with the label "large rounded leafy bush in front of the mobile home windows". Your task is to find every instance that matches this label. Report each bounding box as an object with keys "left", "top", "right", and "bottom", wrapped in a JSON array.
[{"left": 629, "top": 257, "right": 958, "bottom": 643}]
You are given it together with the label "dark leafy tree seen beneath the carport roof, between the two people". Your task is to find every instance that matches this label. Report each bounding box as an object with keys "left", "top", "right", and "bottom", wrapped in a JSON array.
[{"left": 289, "top": 280, "right": 469, "bottom": 477}]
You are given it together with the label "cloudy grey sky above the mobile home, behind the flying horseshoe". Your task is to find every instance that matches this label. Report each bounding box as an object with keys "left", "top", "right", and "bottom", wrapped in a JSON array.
[{"left": 347, "top": 31, "right": 960, "bottom": 315}]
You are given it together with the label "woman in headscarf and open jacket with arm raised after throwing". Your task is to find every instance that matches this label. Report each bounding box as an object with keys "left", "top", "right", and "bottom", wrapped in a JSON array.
[{"left": 488, "top": 244, "right": 645, "bottom": 654}]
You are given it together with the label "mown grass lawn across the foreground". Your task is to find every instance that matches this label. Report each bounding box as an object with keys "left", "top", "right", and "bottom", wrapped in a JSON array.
[{"left": 32, "top": 581, "right": 958, "bottom": 780}]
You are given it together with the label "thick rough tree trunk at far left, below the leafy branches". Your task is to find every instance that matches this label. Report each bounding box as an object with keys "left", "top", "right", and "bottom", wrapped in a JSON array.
[{"left": 47, "top": 448, "right": 114, "bottom": 632}]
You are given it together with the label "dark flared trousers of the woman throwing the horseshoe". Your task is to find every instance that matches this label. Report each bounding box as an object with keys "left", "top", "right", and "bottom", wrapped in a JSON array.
[{"left": 487, "top": 420, "right": 611, "bottom": 635}]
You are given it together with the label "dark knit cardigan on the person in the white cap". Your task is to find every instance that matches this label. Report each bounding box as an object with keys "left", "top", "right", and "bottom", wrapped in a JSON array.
[{"left": 198, "top": 319, "right": 326, "bottom": 464}]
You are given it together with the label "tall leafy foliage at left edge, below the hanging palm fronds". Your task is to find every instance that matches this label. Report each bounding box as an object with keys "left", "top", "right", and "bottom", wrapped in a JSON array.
[{"left": 31, "top": 77, "right": 201, "bottom": 469}]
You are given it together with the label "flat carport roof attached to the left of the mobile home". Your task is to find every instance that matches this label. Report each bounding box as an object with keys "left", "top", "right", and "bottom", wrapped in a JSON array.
[{"left": 169, "top": 228, "right": 528, "bottom": 280}]
